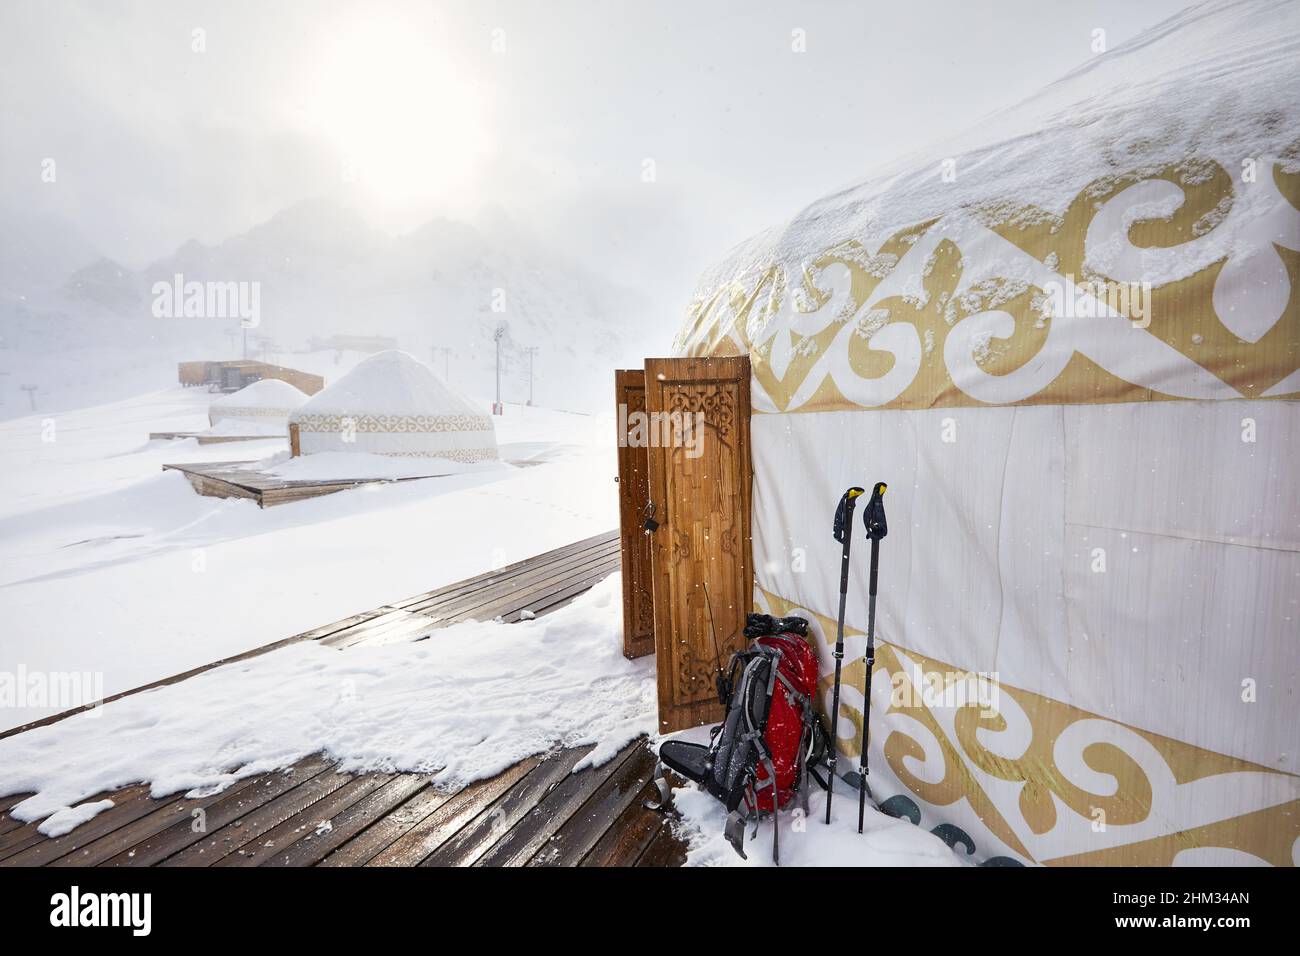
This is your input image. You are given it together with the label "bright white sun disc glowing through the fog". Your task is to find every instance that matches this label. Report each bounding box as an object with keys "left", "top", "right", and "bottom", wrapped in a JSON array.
[{"left": 304, "top": 21, "right": 486, "bottom": 202}]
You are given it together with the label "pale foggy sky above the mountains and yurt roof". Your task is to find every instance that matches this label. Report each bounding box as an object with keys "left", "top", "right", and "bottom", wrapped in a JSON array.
[{"left": 0, "top": 0, "right": 1187, "bottom": 304}]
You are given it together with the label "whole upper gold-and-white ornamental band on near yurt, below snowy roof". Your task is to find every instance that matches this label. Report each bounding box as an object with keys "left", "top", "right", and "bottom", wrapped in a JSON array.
[{"left": 675, "top": 158, "right": 1300, "bottom": 412}]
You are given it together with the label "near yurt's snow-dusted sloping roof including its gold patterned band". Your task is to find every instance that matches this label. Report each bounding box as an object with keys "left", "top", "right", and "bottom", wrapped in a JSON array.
[{"left": 675, "top": 0, "right": 1300, "bottom": 411}]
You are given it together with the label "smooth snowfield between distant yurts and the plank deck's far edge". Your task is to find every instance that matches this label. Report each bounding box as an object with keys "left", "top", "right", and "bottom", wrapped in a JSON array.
[{"left": 0, "top": 386, "right": 618, "bottom": 727}]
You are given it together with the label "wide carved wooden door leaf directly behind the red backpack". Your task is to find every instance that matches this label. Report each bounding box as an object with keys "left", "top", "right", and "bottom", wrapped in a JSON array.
[{"left": 642, "top": 356, "right": 754, "bottom": 734}]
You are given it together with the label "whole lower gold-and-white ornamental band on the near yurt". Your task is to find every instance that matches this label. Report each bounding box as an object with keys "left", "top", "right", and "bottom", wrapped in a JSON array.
[{"left": 755, "top": 589, "right": 1300, "bottom": 866}]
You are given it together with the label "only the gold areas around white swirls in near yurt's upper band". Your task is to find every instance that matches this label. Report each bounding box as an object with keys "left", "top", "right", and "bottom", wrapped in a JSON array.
[{"left": 677, "top": 158, "right": 1300, "bottom": 412}]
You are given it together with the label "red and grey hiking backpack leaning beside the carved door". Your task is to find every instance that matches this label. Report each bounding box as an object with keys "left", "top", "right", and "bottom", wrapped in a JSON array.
[{"left": 655, "top": 614, "right": 828, "bottom": 864}]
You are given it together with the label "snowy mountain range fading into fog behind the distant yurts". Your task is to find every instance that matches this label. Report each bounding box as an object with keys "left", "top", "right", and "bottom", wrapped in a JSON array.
[{"left": 0, "top": 200, "right": 660, "bottom": 418}]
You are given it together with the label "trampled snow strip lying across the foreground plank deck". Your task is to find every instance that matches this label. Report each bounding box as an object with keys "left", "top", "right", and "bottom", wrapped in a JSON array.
[{"left": 0, "top": 575, "right": 655, "bottom": 831}]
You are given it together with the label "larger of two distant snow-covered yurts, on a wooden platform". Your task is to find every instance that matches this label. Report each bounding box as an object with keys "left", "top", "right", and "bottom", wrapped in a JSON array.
[{"left": 290, "top": 350, "right": 497, "bottom": 462}]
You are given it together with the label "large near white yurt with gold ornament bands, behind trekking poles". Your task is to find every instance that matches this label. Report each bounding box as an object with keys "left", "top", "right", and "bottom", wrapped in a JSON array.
[{"left": 676, "top": 0, "right": 1300, "bottom": 865}]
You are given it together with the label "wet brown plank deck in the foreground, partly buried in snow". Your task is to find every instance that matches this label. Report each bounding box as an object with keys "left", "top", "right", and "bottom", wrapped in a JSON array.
[{"left": 0, "top": 532, "right": 685, "bottom": 866}]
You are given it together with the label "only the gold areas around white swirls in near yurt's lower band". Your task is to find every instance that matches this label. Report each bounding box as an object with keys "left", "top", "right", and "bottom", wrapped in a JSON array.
[{"left": 757, "top": 588, "right": 1300, "bottom": 866}]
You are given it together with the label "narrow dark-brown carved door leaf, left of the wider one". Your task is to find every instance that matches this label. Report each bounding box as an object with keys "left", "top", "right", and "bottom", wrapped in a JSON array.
[{"left": 614, "top": 368, "right": 654, "bottom": 657}]
